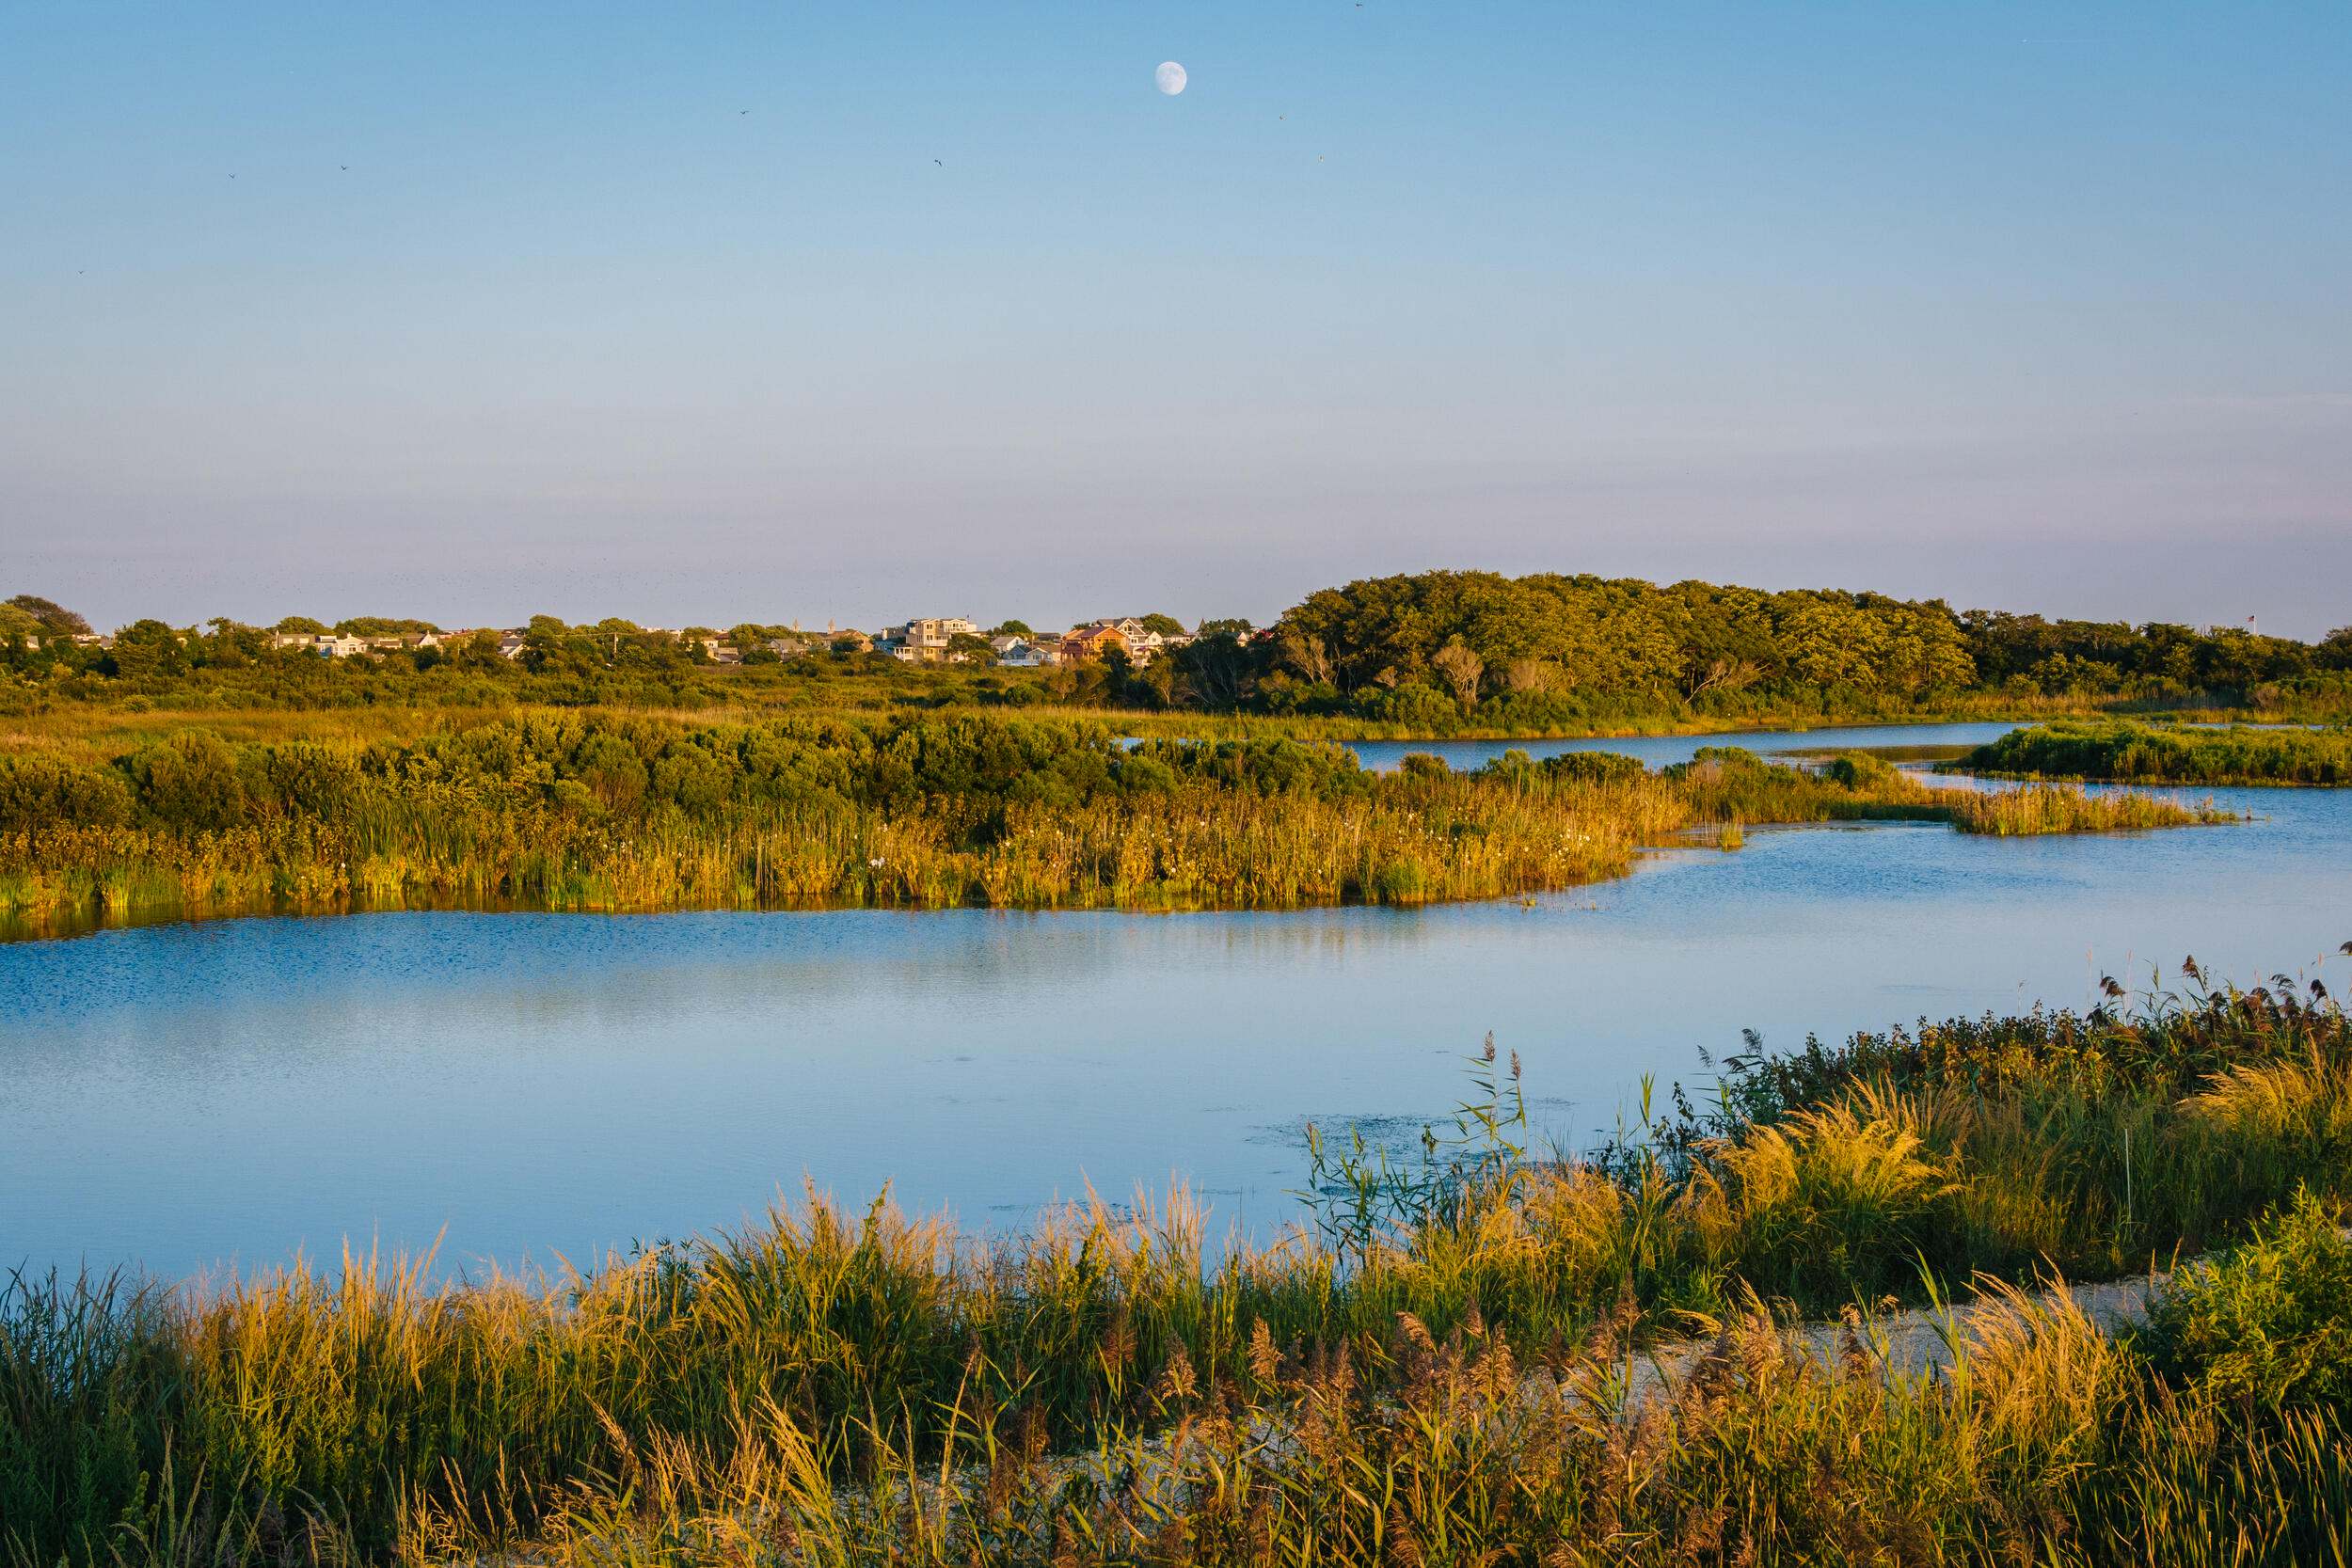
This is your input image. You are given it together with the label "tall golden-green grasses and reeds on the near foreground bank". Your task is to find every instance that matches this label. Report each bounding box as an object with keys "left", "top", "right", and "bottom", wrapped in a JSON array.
[{"left": 0, "top": 964, "right": 2352, "bottom": 1563}]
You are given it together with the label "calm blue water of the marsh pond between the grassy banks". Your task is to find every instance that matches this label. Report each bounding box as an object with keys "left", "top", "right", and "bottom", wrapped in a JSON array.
[{"left": 0, "top": 726, "right": 2352, "bottom": 1275}]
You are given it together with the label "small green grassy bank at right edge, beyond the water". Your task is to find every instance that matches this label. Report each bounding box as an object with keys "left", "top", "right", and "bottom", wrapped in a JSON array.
[{"left": 1957, "top": 721, "right": 2352, "bottom": 785}]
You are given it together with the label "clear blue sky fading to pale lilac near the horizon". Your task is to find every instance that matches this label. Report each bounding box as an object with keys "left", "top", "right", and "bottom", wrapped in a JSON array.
[{"left": 0, "top": 0, "right": 2352, "bottom": 637}]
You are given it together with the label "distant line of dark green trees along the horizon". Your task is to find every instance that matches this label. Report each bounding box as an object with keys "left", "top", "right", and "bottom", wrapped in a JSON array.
[{"left": 0, "top": 571, "right": 2352, "bottom": 734}]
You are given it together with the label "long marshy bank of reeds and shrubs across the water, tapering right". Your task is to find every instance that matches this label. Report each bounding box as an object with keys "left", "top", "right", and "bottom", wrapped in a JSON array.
[{"left": 0, "top": 712, "right": 2201, "bottom": 933}]
